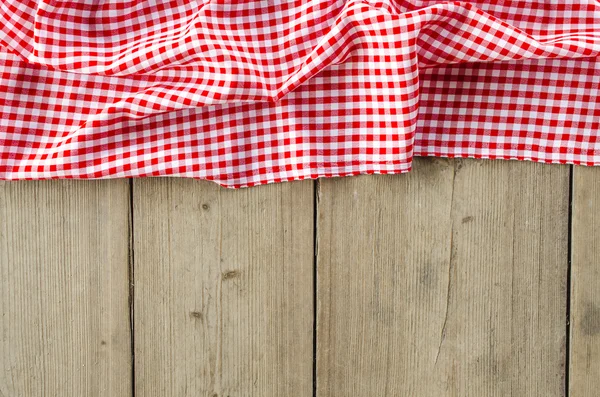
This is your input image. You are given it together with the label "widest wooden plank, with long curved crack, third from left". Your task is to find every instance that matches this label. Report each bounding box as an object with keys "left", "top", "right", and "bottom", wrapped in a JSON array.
[{"left": 317, "top": 159, "right": 569, "bottom": 397}]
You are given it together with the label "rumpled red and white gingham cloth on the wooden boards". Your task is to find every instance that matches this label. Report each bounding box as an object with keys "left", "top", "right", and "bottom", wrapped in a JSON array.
[{"left": 0, "top": 0, "right": 600, "bottom": 187}]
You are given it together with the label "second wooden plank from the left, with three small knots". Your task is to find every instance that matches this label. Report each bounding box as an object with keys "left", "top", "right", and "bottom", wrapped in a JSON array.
[{"left": 134, "top": 178, "right": 314, "bottom": 397}]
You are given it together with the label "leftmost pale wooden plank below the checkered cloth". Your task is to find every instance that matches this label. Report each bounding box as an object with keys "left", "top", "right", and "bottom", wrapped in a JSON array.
[{"left": 0, "top": 181, "right": 131, "bottom": 396}]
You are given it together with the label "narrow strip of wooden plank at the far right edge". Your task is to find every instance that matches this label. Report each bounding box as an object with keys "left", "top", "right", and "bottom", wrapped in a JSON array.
[{"left": 569, "top": 167, "right": 600, "bottom": 397}]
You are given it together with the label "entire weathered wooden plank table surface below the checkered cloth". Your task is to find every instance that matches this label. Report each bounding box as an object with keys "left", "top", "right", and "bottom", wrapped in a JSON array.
[{"left": 0, "top": 159, "right": 600, "bottom": 397}]
